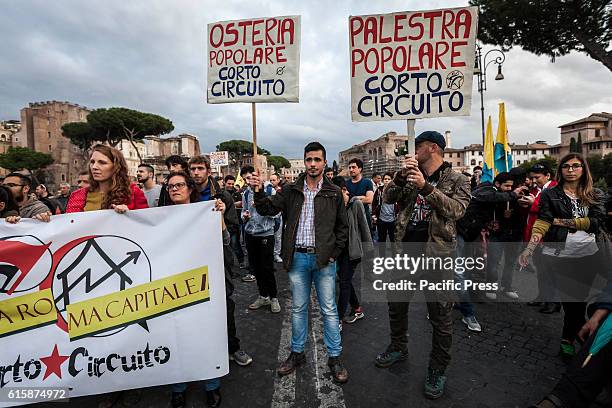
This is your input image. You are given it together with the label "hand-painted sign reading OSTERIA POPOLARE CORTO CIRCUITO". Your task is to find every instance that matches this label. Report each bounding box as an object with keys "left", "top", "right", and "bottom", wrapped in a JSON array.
[{"left": 207, "top": 16, "right": 300, "bottom": 103}]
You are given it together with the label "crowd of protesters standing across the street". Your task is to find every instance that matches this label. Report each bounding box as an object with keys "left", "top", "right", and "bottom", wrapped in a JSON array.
[{"left": 0, "top": 131, "right": 612, "bottom": 407}]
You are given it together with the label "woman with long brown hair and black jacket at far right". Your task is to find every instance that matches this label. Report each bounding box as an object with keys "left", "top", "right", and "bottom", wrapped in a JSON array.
[{"left": 519, "top": 153, "right": 606, "bottom": 361}]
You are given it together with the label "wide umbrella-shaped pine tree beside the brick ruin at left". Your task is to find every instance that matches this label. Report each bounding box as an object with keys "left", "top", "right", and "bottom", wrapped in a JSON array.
[{"left": 87, "top": 108, "right": 174, "bottom": 161}]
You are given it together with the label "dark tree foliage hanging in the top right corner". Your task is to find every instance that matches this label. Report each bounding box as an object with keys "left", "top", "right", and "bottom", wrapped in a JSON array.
[{"left": 470, "top": 0, "right": 612, "bottom": 71}]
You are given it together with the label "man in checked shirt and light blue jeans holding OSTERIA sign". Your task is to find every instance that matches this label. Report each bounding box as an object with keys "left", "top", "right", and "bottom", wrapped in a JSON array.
[{"left": 251, "top": 142, "right": 348, "bottom": 383}]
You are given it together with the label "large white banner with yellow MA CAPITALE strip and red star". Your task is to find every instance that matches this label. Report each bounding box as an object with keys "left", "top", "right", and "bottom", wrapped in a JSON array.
[{"left": 0, "top": 202, "right": 229, "bottom": 407}]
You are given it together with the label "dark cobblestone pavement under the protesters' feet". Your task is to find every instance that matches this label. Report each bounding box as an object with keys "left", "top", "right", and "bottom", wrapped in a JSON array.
[{"left": 34, "top": 264, "right": 592, "bottom": 408}]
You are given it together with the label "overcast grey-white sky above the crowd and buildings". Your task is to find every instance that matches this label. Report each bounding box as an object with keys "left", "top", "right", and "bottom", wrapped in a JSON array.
[{"left": 0, "top": 0, "right": 612, "bottom": 158}]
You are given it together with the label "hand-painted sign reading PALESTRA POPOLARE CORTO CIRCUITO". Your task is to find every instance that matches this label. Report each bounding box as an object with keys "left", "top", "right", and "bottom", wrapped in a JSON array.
[{"left": 349, "top": 7, "right": 478, "bottom": 121}]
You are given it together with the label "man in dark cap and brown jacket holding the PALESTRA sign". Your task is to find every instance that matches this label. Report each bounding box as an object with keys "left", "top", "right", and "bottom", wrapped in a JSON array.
[{"left": 376, "top": 131, "right": 470, "bottom": 399}]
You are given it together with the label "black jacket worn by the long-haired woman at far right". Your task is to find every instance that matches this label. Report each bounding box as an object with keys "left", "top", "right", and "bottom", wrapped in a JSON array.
[{"left": 538, "top": 185, "right": 606, "bottom": 243}]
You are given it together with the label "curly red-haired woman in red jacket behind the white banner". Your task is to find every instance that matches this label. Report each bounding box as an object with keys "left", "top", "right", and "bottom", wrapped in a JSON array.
[{"left": 66, "top": 145, "right": 148, "bottom": 214}]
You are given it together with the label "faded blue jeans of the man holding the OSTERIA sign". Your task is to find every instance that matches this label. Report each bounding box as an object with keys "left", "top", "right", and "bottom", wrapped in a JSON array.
[{"left": 289, "top": 252, "right": 342, "bottom": 357}]
